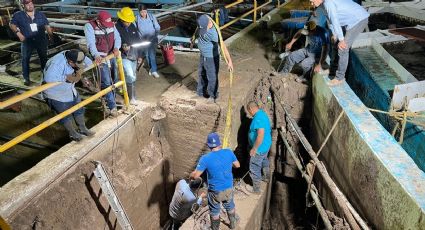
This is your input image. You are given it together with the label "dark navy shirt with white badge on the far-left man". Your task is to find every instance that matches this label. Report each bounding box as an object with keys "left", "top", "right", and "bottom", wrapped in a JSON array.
[{"left": 10, "top": 10, "right": 49, "bottom": 39}]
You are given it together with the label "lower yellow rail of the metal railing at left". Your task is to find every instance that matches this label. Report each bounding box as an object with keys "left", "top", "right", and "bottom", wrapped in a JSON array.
[{"left": 0, "top": 81, "right": 124, "bottom": 153}]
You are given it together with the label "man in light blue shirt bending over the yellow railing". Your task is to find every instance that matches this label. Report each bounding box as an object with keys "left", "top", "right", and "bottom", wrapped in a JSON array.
[{"left": 43, "top": 49, "right": 94, "bottom": 141}]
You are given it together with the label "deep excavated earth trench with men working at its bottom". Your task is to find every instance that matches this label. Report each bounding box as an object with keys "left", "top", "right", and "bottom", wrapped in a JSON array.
[{"left": 0, "top": 65, "right": 344, "bottom": 229}]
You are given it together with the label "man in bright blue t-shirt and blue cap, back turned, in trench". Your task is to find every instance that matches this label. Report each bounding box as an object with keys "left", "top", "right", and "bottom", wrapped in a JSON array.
[{"left": 190, "top": 133, "right": 240, "bottom": 230}]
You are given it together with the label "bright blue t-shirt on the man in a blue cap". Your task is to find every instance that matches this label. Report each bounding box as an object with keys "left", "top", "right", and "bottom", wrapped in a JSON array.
[{"left": 196, "top": 149, "right": 237, "bottom": 192}]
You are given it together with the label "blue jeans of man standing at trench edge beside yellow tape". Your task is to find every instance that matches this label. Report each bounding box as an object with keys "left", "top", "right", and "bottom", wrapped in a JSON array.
[{"left": 196, "top": 55, "right": 220, "bottom": 99}]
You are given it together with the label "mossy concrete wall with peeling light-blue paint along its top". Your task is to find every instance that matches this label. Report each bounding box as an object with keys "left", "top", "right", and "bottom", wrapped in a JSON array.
[{"left": 312, "top": 75, "right": 425, "bottom": 229}]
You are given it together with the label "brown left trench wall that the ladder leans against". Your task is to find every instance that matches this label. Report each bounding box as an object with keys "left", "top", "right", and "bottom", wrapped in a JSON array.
[{"left": 0, "top": 105, "right": 173, "bottom": 229}]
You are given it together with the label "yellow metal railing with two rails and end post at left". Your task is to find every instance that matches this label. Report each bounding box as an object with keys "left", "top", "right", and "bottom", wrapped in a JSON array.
[{"left": 0, "top": 54, "right": 129, "bottom": 153}]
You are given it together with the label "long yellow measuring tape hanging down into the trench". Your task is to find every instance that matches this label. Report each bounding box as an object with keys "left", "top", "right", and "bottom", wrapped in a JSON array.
[{"left": 208, "top": 16, "right": 233, "bottom": 148}]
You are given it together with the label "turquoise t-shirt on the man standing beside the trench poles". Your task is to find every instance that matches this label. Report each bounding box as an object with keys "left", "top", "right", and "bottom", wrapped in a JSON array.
[{"left": 248, "top": 109, "right": 272, "bottom": 155}]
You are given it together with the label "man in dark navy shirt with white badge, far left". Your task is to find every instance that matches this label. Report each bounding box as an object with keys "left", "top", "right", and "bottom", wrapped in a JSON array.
[{"left": 9, "top": 0, "right": 53, "bottom": 86}]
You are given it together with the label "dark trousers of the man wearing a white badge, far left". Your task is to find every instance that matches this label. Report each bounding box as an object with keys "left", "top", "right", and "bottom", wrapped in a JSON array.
[{"left": 21, "top": 38, "right": 48, "bottom": 81}]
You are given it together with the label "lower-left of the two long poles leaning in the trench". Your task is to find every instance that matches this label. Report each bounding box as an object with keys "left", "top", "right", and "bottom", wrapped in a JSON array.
[{"left": 279, "top": 128, "right": 333, "bottom": 230}]
